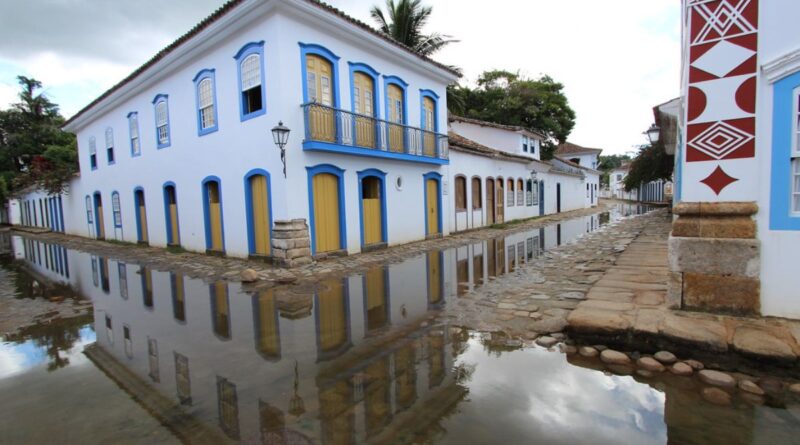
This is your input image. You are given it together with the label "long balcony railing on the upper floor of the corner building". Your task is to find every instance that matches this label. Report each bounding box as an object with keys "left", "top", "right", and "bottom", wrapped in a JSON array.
[{"left": 303, "top": 103, "right": 449, "bottom": 160}]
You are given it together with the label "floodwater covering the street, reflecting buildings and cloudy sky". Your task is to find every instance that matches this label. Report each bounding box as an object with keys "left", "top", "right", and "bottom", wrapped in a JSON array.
[{"left": 0, "top": 206, "right": 800, "bottom": 444}]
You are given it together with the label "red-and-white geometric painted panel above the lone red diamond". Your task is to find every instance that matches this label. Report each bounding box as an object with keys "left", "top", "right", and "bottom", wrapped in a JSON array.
[{"left": 686, "top": 0, "right": 758, "bottom": 164}]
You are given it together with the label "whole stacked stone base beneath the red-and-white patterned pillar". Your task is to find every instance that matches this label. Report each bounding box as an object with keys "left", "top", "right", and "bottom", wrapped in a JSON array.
[{"left": 667, "top": 202, "right": 761, "bottom": 315}]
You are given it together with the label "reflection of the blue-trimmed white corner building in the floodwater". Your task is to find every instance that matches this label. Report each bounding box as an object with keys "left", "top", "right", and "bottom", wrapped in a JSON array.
[{"left": 4, "top": 206, "right": 664, "bottom": 444}]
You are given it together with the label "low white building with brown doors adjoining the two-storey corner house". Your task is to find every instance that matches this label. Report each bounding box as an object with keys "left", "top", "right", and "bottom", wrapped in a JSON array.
[{"left": 448, "top": 116, "right": 599, "bottom": 231}]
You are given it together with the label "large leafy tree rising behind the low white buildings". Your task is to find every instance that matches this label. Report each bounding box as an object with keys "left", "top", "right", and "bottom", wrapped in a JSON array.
[{"left": 447, "top": 70, "right": 575, "bottom": 159}]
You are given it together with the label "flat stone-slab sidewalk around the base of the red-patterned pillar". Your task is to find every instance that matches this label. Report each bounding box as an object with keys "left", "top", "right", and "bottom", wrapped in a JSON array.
[{"left": 567, "top": 212, "right": 800, "bottom": 365}]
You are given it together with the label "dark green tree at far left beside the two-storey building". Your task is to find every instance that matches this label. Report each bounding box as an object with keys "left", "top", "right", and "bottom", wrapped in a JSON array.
[{"left": 0, "top": 76, "right": 78, "bottom": 200}]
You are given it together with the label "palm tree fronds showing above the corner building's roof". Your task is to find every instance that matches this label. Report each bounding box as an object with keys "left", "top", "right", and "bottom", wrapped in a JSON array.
[{"left": 370, "top": 0, "right": 457, "bottom": 56}]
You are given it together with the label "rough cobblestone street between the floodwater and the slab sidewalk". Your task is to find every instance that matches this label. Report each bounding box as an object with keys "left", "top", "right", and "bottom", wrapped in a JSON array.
[{"left": 444, "top": 209, "right": 669, "bottom": 340}]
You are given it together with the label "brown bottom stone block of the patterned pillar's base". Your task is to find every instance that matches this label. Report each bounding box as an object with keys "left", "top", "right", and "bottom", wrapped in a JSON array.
[{"left": 683, "top": 272, "right": 761, "bottom": 315}]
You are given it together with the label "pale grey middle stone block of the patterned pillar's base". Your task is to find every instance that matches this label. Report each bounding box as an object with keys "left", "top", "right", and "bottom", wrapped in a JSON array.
[{"left": 669, "top": 235, "right": 761, "bottom": 278}]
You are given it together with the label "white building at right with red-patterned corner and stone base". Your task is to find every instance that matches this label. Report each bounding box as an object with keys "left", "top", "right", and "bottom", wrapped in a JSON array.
[{"left": 662, "top": 0, "right": 800, "bottom": 318}]
